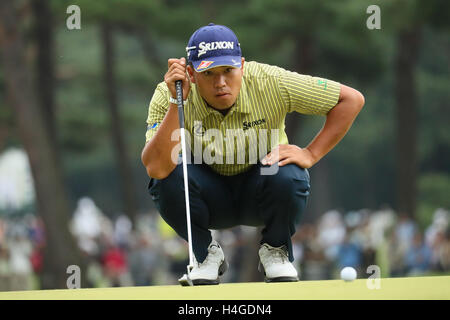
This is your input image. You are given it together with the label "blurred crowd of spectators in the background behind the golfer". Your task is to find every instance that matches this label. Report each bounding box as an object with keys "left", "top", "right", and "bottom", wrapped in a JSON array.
[{"left": 0, "top": 198, "right": 450, "bottom": 291}]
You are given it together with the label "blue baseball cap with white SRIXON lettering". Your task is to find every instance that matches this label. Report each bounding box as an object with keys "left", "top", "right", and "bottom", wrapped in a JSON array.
[{"left": 186, "top": 23, "right": 242, "bottom": 72}]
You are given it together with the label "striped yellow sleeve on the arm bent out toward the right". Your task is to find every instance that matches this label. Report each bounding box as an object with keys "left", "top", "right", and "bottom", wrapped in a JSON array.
[{"left": 280, "top": 70, "right": 341, "bottom": 115}]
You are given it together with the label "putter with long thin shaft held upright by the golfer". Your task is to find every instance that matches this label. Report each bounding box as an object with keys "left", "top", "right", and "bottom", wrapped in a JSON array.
[{"left": 175, "top": 80, "right": 194, "bottom": 287}]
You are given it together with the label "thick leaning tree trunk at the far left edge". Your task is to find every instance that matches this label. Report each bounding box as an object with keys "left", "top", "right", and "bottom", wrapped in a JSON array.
[{"left": 0, "top": 0, "right": 85, "bottom": 289}]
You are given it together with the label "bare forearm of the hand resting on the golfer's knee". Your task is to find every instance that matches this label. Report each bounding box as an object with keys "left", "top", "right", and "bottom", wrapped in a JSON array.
[{"left": 306, "top": 87, "right": 364, "bottom": 168}]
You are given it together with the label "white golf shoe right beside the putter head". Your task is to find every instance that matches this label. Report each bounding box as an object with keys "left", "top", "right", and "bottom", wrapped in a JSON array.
[{"left": 189, "top": 240, "right": 228, "bottom": 285}]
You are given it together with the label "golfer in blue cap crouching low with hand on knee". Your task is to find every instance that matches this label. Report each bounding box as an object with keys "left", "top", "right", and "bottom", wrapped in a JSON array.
[{"left": 142, "top": 24, "right": 364, "bottom": 284}]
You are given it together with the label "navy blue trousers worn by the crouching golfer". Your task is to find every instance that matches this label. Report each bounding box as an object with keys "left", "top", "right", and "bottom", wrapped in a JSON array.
[{"left": 148, "top": 163, "right": 310, "bottom": 262}]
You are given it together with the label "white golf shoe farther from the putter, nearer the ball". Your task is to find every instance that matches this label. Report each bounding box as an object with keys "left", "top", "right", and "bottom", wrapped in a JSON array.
[{"left": 258, "top": 243, "right": 298, "bottom": 282}]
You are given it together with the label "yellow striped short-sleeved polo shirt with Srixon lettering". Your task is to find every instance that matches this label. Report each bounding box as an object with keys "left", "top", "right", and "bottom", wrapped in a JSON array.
[{"left": 146, "top": 61, "right": 340, "bottom": 176}]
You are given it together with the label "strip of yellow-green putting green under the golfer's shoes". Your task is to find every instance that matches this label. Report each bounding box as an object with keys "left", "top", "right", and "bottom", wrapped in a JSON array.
[{"left": 0, "top": 276, "right": 450, "bottom": 300}]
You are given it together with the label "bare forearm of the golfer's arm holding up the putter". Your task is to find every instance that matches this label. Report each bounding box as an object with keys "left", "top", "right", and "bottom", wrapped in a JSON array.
[{"left": 141, "top": 104, "right": 180, "bottom": 179}]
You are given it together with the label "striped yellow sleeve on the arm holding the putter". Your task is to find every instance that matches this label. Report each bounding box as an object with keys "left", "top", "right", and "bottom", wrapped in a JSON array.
[{"left": 145, "top": 82, "right": 169, "bottom": 142}]
